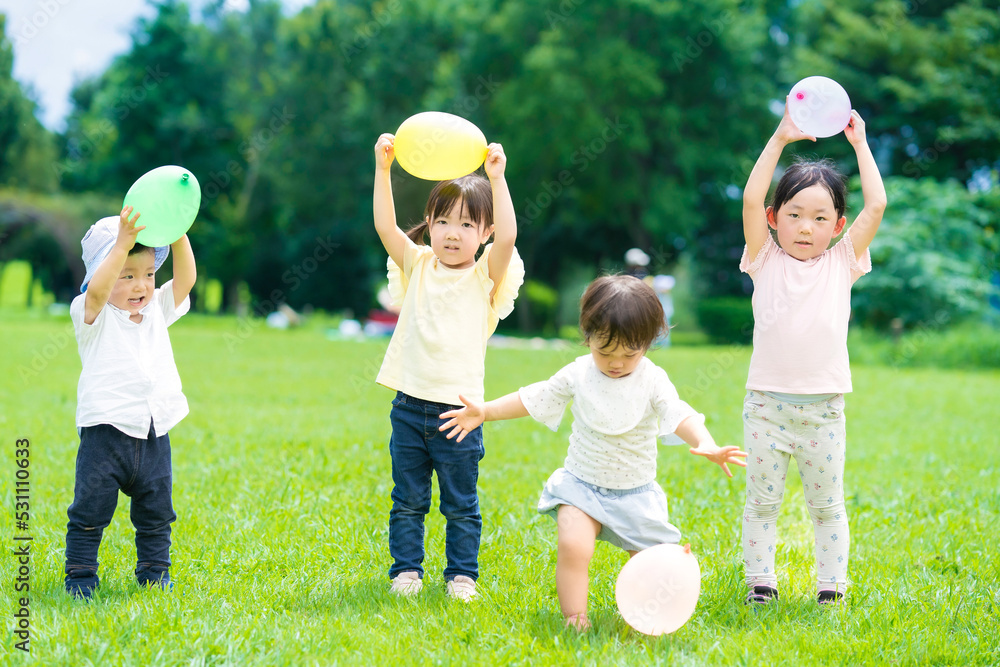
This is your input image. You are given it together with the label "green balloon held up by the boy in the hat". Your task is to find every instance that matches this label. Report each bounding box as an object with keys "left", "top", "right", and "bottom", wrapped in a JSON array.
[{"left": 122, "top": 165, "right": 201, "bottom": 248}]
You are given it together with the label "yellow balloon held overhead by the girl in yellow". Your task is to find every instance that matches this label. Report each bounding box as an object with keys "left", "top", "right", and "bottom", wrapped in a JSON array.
[{"left": 393, "top": 111, "right": 487, "bottom": 181}]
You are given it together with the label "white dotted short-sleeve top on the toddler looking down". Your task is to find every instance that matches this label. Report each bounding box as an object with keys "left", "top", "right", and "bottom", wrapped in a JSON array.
[{"left": 518, "top": 354, "right": 705, "bottom": 489}]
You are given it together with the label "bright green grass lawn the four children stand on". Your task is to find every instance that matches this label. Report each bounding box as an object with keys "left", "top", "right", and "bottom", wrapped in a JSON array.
[{"left": 0, "top": 315, "right": 1000, "bottom": 666}]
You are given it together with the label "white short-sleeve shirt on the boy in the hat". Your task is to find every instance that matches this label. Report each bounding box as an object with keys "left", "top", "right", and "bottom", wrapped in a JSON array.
[{"left": 69, "top": 280, "right": 191, "bottom": 438}]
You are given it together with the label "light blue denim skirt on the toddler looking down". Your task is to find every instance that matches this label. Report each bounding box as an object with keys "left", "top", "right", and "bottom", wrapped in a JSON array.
[{"left": 538, "top": 468, "right": 681, "bottom": 551}]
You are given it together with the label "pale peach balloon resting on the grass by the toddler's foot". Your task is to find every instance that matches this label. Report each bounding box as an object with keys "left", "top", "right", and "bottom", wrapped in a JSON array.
[{"left": 615, "top": 544, "right": 701, "bottom": 635}]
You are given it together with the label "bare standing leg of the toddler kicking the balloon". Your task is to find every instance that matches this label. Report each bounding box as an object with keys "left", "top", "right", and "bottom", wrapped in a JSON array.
[{"left": 556, "top": 505, "right": 601, "bottom": 630}]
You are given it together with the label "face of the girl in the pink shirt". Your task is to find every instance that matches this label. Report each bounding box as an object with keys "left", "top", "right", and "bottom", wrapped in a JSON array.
[{"left": 767, "top": 188, "right": 847, "bottom": 261}]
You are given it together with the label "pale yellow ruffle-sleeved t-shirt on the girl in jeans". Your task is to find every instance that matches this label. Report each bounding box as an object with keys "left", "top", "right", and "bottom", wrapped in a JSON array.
[{"left": 375, "top": 242, "right": 524, "bottom": 405}]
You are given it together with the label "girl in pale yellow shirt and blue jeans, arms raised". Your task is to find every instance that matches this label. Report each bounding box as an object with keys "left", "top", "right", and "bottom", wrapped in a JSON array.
[{"left": 373, "top": 134, "right": 524, "bottom": 601}]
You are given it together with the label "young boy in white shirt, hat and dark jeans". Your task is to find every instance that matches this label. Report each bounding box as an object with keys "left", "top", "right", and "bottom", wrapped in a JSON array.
[{"left": 66, "top": 206, "right": 196, "bottom": 599}]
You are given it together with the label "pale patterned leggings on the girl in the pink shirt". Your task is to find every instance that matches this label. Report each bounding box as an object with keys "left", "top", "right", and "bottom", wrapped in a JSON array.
[{"left": 743, "top": 390, "right": 851, "bottom": 592}]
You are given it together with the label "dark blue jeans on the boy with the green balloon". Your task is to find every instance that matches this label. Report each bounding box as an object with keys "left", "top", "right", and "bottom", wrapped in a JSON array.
[{"left": 66, "top": 424, "right": 177, "bottom": 591}]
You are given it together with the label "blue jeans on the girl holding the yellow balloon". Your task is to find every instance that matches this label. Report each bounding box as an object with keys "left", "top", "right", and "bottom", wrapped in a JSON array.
[{"left": 389, "top": 392, "right": 485, "bottom": 581}]
